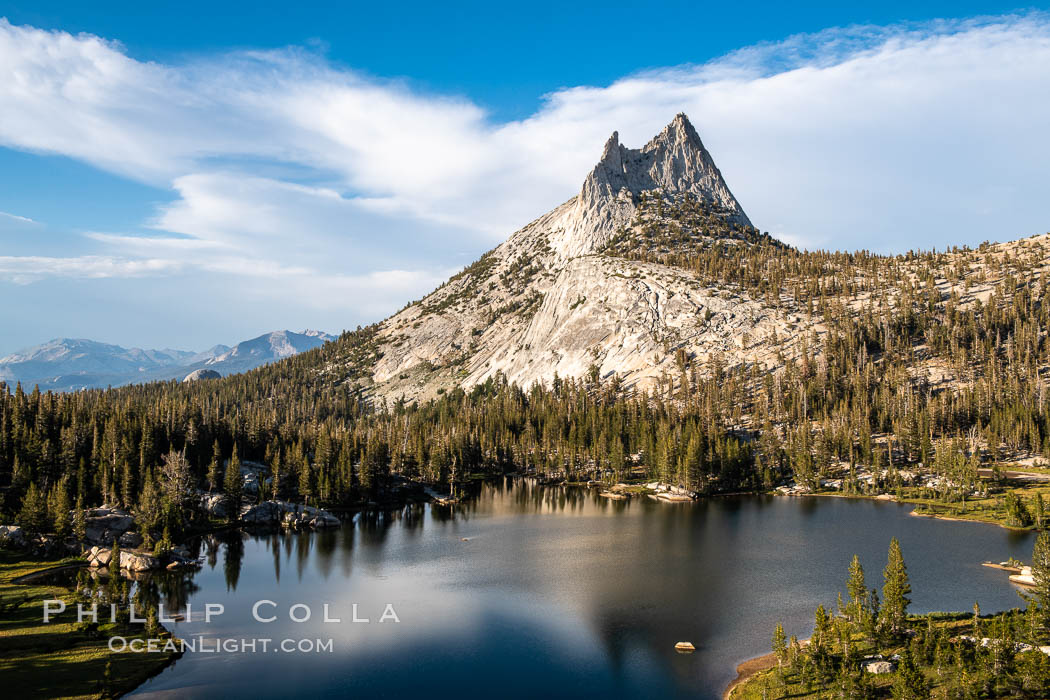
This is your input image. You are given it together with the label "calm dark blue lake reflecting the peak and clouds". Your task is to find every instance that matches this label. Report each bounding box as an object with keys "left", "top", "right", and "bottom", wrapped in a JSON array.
[{"left": 127, "top": 480, "right": 1032, "bottom": 699}]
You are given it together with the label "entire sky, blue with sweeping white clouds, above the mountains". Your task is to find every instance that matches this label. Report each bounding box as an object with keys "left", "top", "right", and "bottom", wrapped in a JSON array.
[{"left": 0, "top": 2, "right": 1050, "bottom": 355}]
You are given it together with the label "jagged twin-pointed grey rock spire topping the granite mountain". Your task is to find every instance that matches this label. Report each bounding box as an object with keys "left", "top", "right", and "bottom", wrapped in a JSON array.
[{"left": 554, "top": 112, "right": 751, "bottom": 257}]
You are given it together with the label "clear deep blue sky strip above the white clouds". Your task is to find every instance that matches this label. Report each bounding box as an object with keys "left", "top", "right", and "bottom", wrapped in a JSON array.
[{"left": 6, "top": 0, "right": 1047, "bottom": 119}]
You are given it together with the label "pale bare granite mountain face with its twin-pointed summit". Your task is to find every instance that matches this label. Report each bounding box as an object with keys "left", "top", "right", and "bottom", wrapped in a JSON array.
[{"left": 336, "top": 114, "right": 800, "bottom": 400}]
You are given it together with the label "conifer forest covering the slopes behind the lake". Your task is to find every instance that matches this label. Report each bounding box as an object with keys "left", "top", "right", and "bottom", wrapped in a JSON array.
[{"left": 0, "top": 196, "right": 1050, "bottom": 527}]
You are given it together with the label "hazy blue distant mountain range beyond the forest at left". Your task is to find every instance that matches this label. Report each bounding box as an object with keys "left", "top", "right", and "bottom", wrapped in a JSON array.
[{"left": 0, "top": 331, "right": 335, "bottom": 391}]
